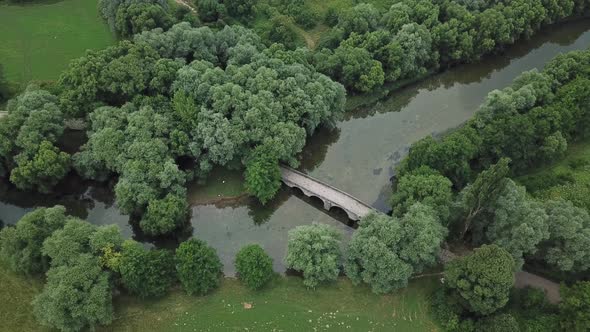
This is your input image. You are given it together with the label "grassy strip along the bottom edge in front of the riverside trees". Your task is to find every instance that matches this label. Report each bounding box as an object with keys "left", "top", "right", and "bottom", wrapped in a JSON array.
[{"left": 0, "top": 260, "right": 438, "bottom": 332}]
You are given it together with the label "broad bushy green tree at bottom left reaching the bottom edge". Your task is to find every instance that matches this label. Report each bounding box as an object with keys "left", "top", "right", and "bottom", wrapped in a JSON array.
[{"left": 33, "top": 254, "right": 113, "bottom": 331}]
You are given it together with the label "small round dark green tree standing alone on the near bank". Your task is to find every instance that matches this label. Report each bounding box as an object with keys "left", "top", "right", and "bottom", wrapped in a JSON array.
[{"left": 236, "top": 244, "right": 273, "bottom": 290}]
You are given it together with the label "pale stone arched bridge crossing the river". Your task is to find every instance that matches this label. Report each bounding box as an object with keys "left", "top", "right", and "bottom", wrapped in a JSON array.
[{"left": 281, "top": 166, "right": 375, "bottom": 221}]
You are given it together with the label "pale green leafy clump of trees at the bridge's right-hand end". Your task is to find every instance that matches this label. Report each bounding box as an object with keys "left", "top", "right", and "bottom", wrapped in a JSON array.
[{"left": 344, "top": 203, "right": 447, "bottom": 293}]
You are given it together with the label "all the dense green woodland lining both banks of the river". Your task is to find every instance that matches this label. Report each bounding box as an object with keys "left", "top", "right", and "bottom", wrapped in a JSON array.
[{"left": 0, "top": 0, "right": 590, "bottom": 331}]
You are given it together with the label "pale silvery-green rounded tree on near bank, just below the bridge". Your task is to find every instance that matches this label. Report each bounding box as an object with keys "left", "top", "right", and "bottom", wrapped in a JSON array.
[{"left": 285, "top": 224, "right": 341, "bottom": 288}]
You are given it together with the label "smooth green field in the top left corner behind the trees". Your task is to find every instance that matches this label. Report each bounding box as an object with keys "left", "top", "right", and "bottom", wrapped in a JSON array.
[{"left": 0, "top": 0, "right": 115, "bottom": 87}]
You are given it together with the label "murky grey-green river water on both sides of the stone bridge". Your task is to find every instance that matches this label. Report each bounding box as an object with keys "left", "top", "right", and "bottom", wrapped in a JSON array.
[{"left": 0, "top": 20, "right": 590, "bottom": 276}]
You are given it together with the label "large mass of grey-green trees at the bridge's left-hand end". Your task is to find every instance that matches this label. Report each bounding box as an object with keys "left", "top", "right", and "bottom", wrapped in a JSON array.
[{"left": 66, "top": 22, "right": 345, "bottom": 223}]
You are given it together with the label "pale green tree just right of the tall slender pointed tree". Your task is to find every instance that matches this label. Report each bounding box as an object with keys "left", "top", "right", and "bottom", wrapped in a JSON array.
[{"left": 486, "top": 179, "right": 549, "bottom": 269}]
